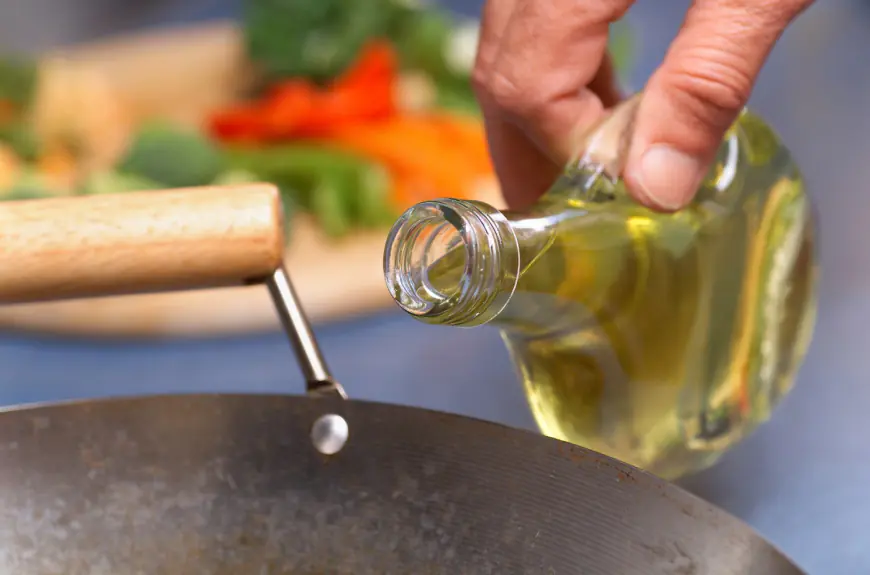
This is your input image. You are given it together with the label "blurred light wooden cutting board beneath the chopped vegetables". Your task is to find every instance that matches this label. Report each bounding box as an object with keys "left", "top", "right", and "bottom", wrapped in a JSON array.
[{"left": 0, "top": 22, "right": 498, "bottom": 337}]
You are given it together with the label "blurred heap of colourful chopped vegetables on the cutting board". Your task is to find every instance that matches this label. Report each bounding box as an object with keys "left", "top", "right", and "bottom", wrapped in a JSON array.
[{"left": 0, "top": 4, "right": 630, "bottom": 249}]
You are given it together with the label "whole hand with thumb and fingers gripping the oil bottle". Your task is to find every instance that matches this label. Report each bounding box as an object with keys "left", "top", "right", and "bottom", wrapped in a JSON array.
[{"left": 473, "top": 0, "right": 812, "bottom": 211}]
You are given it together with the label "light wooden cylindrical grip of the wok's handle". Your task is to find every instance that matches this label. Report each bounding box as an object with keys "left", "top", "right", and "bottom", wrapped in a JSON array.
[{"left": 0, "top": 184, "right": 284, "bottom": 303}]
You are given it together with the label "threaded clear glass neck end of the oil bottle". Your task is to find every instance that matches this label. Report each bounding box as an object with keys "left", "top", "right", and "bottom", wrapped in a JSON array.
[{"left": 384, "top": 199, "right": 520, "bottom": 327}]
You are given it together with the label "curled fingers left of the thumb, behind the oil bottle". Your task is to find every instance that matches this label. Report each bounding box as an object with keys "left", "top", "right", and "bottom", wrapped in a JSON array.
[{"left": 475, "top": 0, "right": 632, "bottom": 209}]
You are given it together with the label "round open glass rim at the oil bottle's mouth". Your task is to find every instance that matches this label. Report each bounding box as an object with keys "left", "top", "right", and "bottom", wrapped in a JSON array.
[{"left": 384, "top": 201, "right": 476, "bottom": 316}]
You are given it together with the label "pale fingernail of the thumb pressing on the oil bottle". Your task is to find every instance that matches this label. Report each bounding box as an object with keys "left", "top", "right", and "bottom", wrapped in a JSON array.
[{"left": 635, "top": 145, "right": 703, "bottom": 210}]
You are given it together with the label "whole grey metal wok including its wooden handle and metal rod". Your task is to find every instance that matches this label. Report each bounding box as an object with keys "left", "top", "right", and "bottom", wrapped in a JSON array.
[{"left": 0, "top": 185, "right": 801, "bottom": 575}]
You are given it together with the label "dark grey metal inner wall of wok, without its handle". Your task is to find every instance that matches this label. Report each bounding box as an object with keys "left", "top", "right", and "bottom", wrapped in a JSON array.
[{"left": 0, "top": 395, "right": 800, "bottom": 575}]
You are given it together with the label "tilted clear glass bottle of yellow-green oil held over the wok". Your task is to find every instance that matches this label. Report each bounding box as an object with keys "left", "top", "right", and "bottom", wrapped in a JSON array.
[{"left": 384, "top": 97, "right": 818, "bottom": 479}]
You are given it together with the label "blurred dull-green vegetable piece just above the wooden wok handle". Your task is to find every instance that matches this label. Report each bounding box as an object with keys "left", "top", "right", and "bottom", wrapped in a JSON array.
[{"left": 118, "top": 123, "right": 224, "bottom": 188}]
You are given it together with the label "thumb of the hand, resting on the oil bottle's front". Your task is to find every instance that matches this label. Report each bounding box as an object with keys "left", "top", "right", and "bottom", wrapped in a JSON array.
[{"left": 624, "top": 0, "right": 810, "bottom": 211}]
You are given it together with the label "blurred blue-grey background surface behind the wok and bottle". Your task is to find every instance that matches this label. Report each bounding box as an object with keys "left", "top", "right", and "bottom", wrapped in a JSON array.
[{"left": 0, "top": 0, "right": 870, "bottom": 575}]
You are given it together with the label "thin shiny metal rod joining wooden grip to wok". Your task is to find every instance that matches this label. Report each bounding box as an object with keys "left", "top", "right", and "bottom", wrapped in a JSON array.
[{"left": 265, "top": 266, "right": 347, "bottom": 398}]
